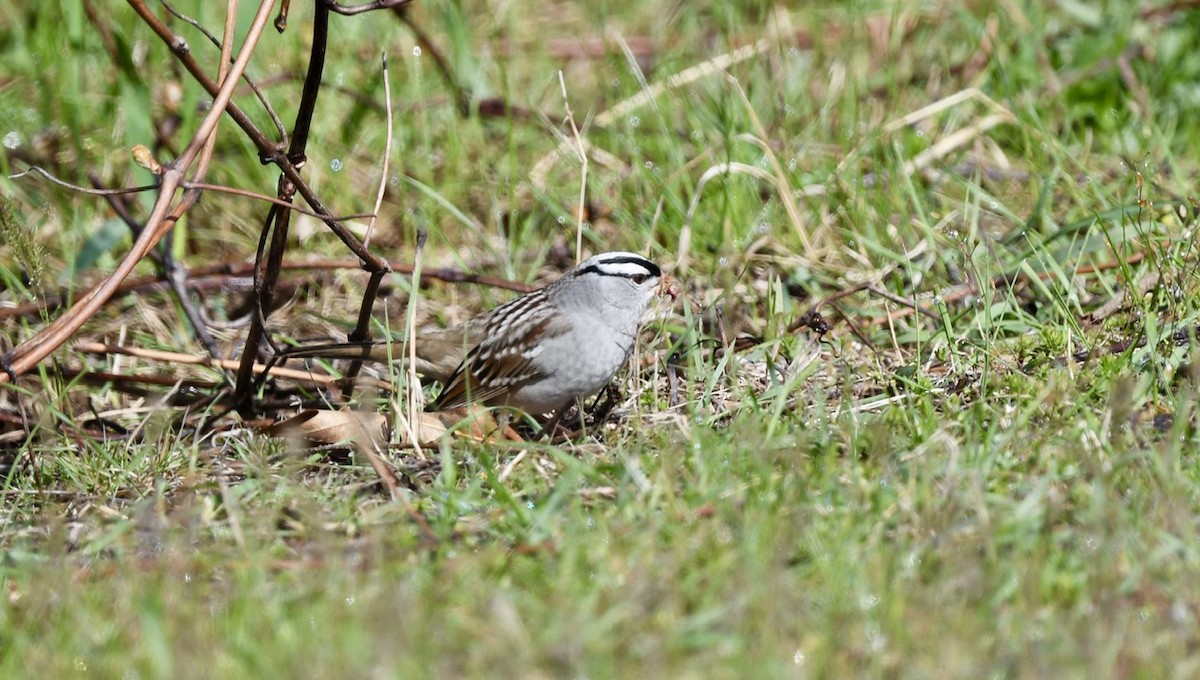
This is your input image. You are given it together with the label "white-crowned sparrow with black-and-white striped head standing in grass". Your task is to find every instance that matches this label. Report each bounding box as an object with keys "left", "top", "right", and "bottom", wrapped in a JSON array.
[{"left": 284, "top": 252, "right": 674, "bottom": 415}]
